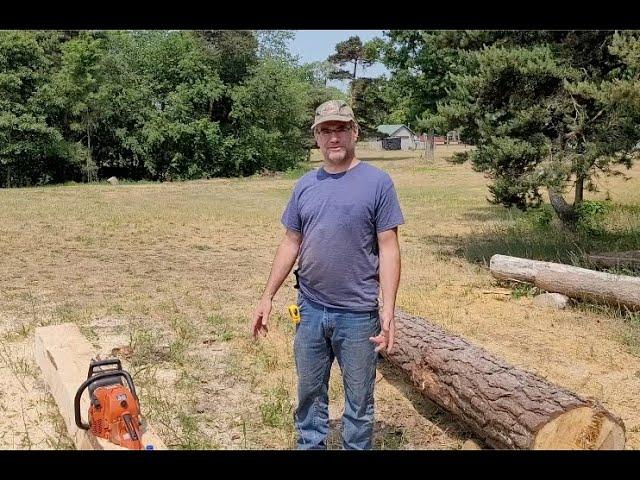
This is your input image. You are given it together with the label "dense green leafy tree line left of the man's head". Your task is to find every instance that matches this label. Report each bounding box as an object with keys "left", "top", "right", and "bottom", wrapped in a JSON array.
[{"left": 0, "top": 30, "right": 341, "bottom": 187}]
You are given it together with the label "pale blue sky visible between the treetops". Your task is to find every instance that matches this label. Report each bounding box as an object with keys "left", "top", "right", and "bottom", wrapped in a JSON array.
[{"left": 289, "top": 30, "right": 388, "bottom": 91}]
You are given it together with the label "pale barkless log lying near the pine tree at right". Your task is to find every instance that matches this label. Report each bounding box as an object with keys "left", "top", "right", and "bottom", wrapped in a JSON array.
[{"left": 489, "top": 255, "right": 640, "bottom": 310}]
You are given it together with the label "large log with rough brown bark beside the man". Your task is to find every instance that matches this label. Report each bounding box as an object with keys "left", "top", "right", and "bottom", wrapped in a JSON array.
[{"left": 384, "top": 311, "right": 625, "bottom": 450}]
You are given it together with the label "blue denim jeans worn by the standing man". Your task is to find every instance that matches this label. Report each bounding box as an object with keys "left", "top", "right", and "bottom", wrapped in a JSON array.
[{"left": 294, "top": 294, "right": 380, "bottom": 450}]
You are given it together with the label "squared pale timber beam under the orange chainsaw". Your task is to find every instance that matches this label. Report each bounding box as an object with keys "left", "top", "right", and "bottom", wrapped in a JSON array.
[{"left": 35, "top": 323, "right": 167, "bottom": 450}]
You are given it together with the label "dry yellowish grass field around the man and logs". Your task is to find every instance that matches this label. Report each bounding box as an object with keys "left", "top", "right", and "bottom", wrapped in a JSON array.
[{"left": 0, "top": 147, "right": 640, "bottom": 449}]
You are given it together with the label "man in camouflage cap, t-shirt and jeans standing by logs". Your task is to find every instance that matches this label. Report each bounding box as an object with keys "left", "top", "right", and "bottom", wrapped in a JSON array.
[{"left": 253, "top": 100, "right": 404, "bottom": 449}]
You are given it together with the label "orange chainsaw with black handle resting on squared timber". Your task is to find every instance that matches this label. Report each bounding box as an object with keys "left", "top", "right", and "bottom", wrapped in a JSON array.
[{"left": 74, "top": 358, "right": 143, "bottom": 450}]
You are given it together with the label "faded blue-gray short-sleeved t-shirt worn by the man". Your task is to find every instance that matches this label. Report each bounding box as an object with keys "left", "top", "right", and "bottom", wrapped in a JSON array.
[{"left": 282, "top": 162, "right": 404, "bottom": 312}]
